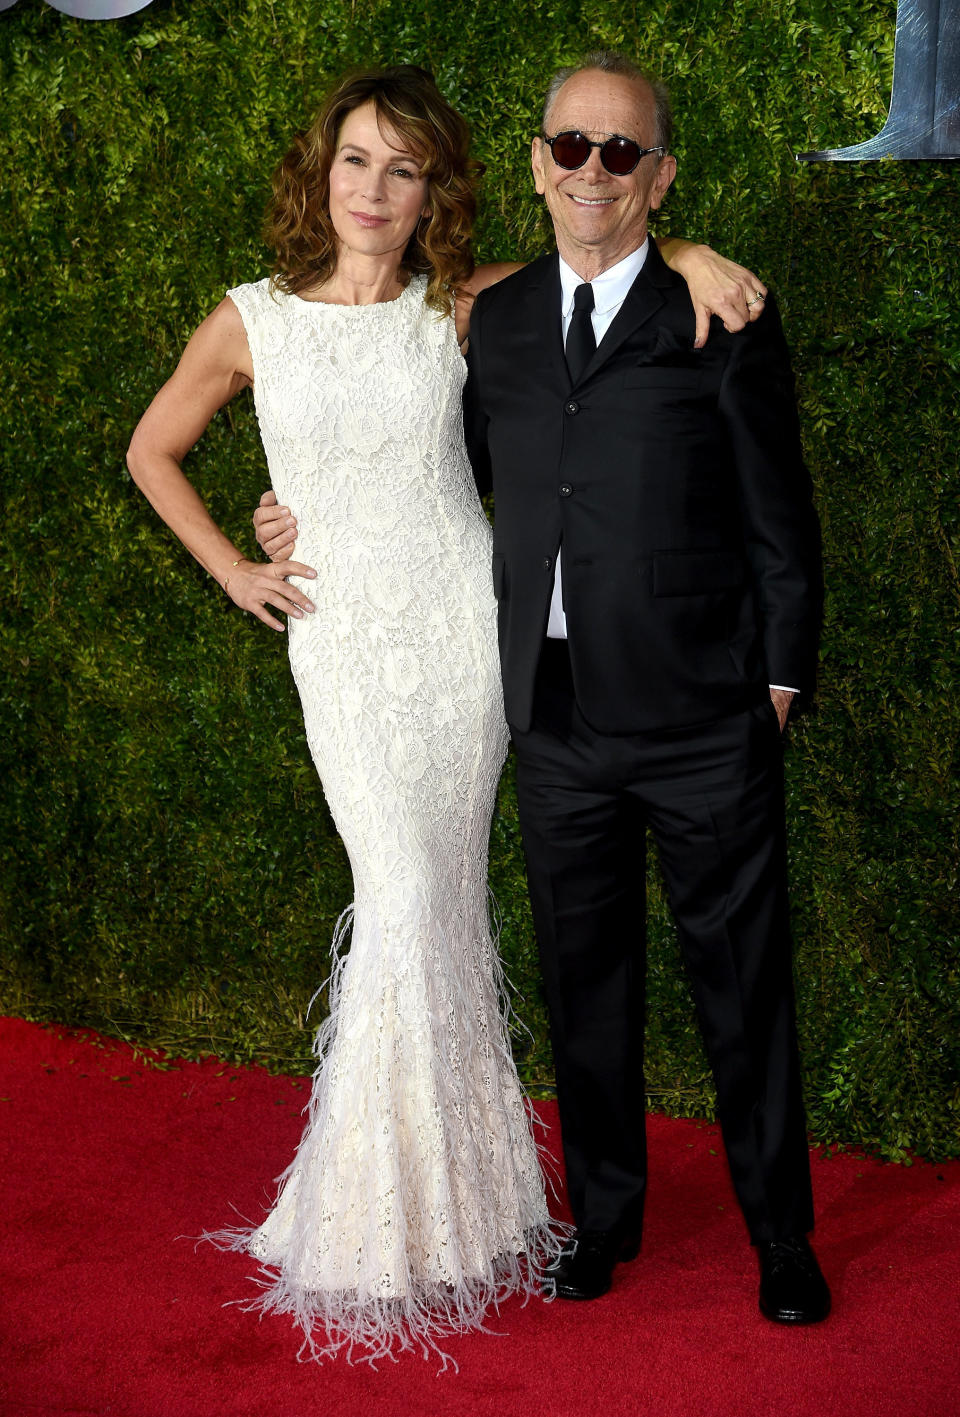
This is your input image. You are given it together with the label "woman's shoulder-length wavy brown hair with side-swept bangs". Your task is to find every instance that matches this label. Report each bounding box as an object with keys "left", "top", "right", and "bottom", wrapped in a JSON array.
[{"left": 265, "top": 64, "right": 484, "bottom": 315}]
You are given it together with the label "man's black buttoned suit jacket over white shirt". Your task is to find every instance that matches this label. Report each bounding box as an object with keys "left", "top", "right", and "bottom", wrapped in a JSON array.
[{"left": 464, "top": 241, "right": 821, "bottom": 734}]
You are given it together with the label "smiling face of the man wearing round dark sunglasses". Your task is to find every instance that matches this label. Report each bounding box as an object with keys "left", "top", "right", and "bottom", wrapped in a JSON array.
[{"left": 530, "top": 69, "right": 676, "bottom": 279}]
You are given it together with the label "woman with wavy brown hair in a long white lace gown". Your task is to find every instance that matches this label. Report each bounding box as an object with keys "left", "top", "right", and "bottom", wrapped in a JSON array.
[{"left": 128, "top": 67, "right": 765, "bottom": 1357}]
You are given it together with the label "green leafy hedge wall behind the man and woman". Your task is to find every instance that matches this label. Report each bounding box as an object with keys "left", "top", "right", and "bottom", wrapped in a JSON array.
[{"left": 0, "top": 0, "right": 960, "bottom": 1158}]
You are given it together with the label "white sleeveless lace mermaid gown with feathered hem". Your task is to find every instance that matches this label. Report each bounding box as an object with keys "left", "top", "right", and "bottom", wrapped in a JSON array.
[{"left": 220, "top": 276, "right": 560, "bottom": 1357}]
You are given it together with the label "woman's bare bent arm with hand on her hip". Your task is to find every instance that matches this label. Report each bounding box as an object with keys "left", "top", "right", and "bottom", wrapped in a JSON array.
[{"left": 126, "top": 299, "right": 315, "bottom": 631}]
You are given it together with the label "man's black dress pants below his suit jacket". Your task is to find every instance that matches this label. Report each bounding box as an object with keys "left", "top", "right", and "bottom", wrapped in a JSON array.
[{"left": 513, "top": 640, "right": 813, "bottom": 1244}]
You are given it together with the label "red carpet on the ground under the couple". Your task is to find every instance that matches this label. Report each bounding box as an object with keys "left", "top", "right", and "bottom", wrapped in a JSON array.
[{"left": 0, "top": 1019, "right": 960, "bottom": 1417}]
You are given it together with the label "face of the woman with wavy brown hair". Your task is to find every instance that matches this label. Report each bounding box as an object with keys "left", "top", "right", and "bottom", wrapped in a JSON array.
[{"left": 330, "top": 102, "right": 430, "bottom": 261}]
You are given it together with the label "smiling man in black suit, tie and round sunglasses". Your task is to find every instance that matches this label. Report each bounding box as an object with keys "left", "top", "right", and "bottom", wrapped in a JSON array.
[{"left": 258, "top": 52, "right": 830, "bottom": 1323}]
